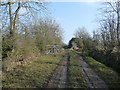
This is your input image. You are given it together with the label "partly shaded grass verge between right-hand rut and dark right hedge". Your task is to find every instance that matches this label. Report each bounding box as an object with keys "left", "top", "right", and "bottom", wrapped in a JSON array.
[{"left": 86, "top": 57, "right": 120, "bottom": 88}]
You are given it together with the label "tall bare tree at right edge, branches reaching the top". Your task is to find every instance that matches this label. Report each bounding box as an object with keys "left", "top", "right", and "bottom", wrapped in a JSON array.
[{"left": 104, "top": 0, "right": 120, "bottom": 48}]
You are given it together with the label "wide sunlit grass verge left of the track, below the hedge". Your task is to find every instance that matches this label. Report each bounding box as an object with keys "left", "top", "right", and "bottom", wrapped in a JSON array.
[{"left": 2, "top": 55, "right": 60, "bottom": 88}]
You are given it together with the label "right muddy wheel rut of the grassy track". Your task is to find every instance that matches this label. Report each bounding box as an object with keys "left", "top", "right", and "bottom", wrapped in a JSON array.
[{"left": 79, "top": 56, "right": 108, "bottom": 90}]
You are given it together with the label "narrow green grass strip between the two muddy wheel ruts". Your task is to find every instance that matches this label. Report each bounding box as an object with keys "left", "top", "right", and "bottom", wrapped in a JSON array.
[{"left": 68, "top": 53, "right": 87, "bottom": 88}]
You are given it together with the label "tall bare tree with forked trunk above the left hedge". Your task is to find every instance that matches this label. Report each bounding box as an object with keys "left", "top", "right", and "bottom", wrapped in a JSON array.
[{"left": 0, "top": 0, "right": 46, "bottom": 34}]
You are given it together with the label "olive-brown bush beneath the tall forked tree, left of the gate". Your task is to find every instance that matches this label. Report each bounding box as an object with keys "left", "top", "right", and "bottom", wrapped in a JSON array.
[{"left": 3, "top": 34, "right": 39, "bottom": 71}]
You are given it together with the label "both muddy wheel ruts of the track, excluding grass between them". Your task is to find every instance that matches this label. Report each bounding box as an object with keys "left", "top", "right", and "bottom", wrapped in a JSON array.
[{"left": 46, "top": 55, "right": 108, "bottom": 90}]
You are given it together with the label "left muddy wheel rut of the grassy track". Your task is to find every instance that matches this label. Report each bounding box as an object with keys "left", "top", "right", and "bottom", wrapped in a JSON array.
[{"left": 47, "top": 55, "right": 68, "bottom": 88}]
